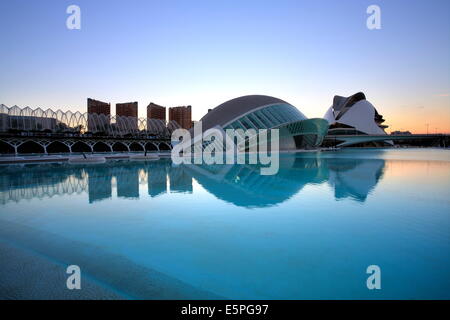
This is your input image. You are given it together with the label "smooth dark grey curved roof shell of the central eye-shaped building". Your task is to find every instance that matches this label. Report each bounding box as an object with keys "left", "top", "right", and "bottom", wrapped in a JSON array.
[{"left": 200, "top": 95, "right": 289, "bottom": 130}]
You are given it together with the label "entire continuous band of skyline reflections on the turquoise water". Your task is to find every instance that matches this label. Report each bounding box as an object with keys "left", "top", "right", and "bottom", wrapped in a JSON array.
[{"left": 0, "top": 153, "right": 385, "bottom": 208}]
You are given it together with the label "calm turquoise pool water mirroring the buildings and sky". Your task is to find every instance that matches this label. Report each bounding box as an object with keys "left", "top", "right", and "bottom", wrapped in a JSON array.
[{"left": 0, "top": 149, "right": 450, "bottom": 299}]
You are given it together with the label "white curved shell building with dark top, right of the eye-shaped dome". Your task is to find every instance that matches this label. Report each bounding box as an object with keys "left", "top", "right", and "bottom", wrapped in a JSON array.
[{"left": 324, "top": 92, "right": 386, "bottom": 134}]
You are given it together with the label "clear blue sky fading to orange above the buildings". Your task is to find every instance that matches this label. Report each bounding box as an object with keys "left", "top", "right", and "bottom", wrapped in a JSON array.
[{"left": 0, "top": 0, "right": 450, "bottom": 133}]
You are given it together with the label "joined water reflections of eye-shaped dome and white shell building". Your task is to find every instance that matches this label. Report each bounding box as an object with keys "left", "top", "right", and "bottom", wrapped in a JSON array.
[{"left": 187, "top": 155, "right": 385, "bottom": 208}]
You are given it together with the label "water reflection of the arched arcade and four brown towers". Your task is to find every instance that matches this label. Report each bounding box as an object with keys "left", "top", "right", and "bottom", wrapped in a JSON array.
[{"left": 0, "top": 159, "right": 192, "bottom": 204}]
